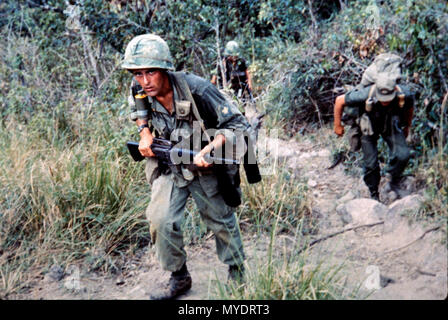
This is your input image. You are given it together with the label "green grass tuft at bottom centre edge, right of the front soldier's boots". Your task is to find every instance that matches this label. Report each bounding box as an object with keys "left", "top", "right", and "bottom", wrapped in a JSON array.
[{"left": 215, "top": 215, "right": 357, "bottom": 300}]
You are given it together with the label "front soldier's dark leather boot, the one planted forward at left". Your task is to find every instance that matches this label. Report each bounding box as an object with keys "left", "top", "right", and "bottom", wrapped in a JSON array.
[{"left": 149, "top": 265, "right": 191, "bottom": 300}]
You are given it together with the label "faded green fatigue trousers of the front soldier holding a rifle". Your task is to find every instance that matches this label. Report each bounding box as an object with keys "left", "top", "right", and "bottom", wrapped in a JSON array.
[{"left": 146, "top": 175, "right": 245, "bottom": 272}]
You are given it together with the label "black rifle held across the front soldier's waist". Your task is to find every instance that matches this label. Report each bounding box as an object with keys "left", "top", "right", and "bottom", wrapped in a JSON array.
[{"left": 126, "top": 138, "right": 240, "bottom": 165}]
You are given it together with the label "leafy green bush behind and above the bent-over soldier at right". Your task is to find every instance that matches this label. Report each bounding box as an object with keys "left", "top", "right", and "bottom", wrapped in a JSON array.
[{"left": 257, "top": 1, "right": 448, "bottom": 136}]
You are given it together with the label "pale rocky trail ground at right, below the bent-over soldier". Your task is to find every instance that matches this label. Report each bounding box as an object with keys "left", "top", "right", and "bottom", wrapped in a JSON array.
[{"left": 274, "top": 129, "right": 448, "bottom": 299}]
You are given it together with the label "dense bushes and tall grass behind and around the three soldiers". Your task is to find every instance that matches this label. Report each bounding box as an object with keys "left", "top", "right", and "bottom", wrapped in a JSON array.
[{"left": 0, "top": 0, "right": 448, "bottom": 298}]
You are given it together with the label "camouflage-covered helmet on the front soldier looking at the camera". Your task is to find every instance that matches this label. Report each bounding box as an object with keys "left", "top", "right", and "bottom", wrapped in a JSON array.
[{"left": 121, "top": 34, "right": 174, "bottom": 70}]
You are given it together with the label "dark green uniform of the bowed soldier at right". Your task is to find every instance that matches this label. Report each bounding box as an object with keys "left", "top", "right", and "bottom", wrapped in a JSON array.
[{"left": 344, "top": 85, "right": 414, "bottom": 192}]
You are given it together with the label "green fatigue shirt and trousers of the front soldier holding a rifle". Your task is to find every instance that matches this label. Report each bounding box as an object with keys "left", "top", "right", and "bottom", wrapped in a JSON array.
[{"left": 129, "top": 72, "right": 249, "bottom": 271}]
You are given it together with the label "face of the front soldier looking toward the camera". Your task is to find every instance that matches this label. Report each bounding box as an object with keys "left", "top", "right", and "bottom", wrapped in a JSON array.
[{"left": 132, "top": 69, "right": 169, "bottom": 97}]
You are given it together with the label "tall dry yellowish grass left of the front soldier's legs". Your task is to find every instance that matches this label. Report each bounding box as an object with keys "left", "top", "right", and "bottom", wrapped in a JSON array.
[{"left": 0, "top": 114, "right": 149, "bottom": 297}]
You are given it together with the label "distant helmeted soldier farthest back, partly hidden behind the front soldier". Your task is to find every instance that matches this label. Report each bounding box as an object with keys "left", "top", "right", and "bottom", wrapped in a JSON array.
[{"left": 211, "top": 41, "right": 253, "bottom": 103}]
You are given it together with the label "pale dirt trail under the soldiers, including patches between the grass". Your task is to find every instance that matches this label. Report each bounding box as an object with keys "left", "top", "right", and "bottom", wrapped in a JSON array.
[{"left": 17, "top": 129, "right": 447, "bottom": 299}]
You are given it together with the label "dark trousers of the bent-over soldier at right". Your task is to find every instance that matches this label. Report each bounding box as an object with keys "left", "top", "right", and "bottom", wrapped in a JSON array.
[{"left": 361, "top": 124, "right": 410, "bottom": 192}]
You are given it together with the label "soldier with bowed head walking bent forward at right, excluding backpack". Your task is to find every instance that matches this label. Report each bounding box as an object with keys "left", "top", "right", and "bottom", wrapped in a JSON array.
[{"left": 334, "top": 72, "right": 414, "bottom": 201}]
